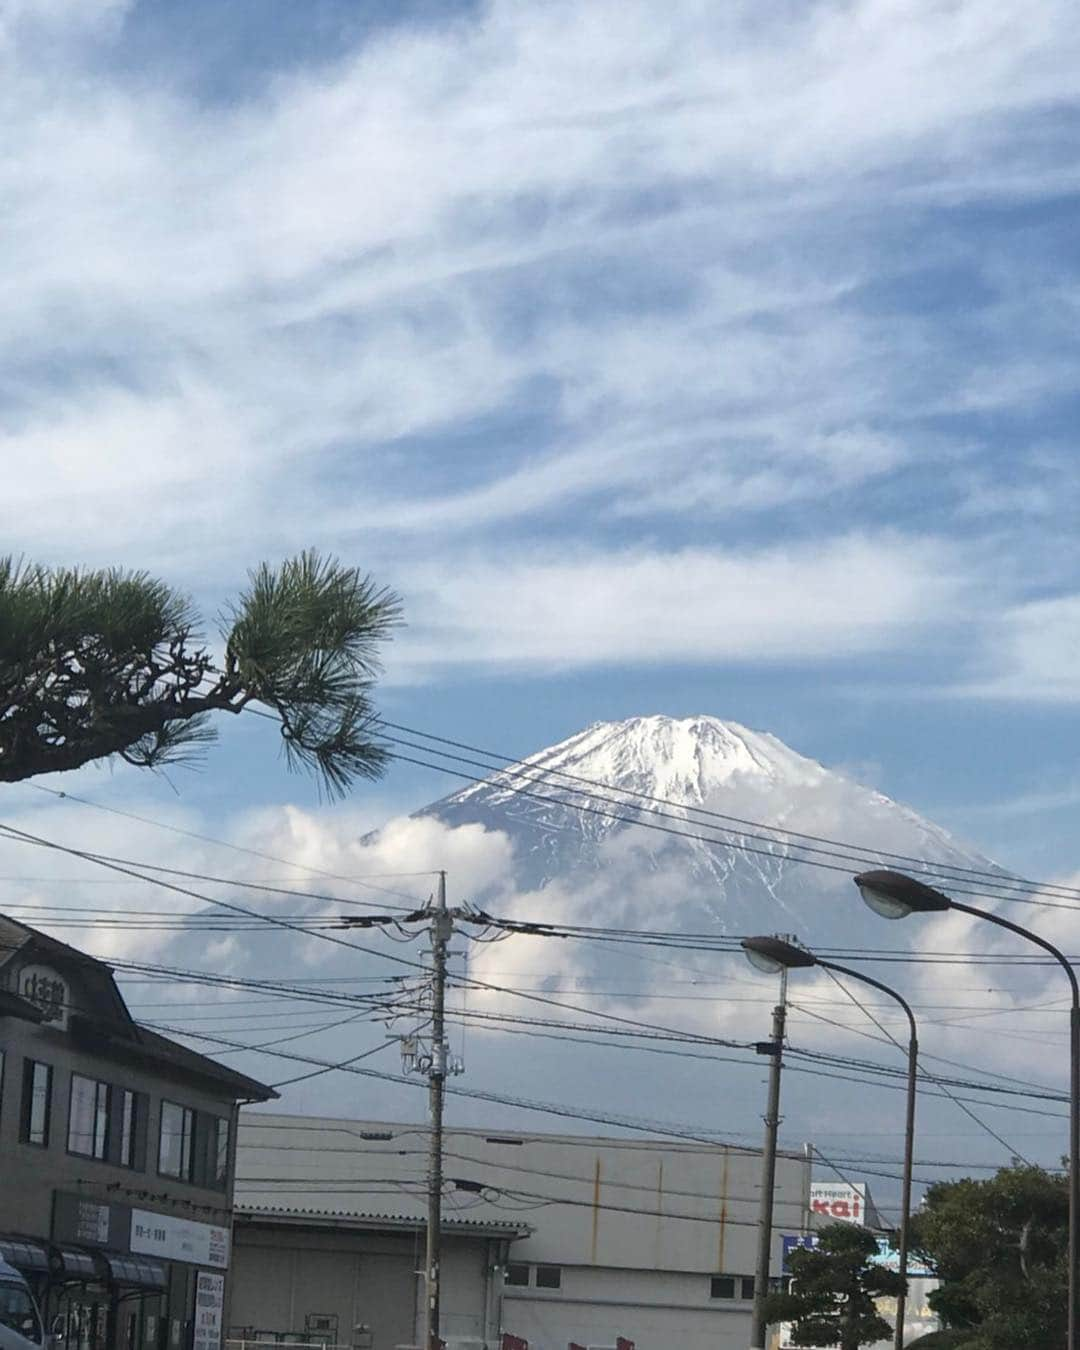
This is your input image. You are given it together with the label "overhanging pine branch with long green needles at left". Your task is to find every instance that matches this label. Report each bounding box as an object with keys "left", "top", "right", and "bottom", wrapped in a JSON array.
[{"left": 0, "top": 552, "right": 400, "bottom": 795}]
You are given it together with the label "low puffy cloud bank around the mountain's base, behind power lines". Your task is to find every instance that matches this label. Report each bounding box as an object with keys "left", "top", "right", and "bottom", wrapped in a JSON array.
[{"left": 4, "top": 750, "right": 1077, "bottom": 1161}]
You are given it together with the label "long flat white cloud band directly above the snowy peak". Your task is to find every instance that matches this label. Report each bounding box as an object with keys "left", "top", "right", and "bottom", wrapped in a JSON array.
[{"left": 394, "top": 536, "right": 963, "bottom": 668}]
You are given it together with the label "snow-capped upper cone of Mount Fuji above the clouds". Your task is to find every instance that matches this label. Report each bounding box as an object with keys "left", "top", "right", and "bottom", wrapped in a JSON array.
[{"left": 417, "top": 716, "right": 998, "bottom": 946}]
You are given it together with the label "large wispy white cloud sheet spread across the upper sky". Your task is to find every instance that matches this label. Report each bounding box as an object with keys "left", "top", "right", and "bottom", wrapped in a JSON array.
[{"left": 0, "top": 0, "right": 1076, "bottom": 664}]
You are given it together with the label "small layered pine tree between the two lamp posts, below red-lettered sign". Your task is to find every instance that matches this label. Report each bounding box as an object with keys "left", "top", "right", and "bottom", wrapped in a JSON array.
[{"left": 765, "top": 1223, "right": 903, "bottom": 1350}]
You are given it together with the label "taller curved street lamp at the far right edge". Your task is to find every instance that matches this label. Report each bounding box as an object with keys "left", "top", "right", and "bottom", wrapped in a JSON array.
[{"left": 855, "top": 871, "right": 1080, "bottom": 1350}]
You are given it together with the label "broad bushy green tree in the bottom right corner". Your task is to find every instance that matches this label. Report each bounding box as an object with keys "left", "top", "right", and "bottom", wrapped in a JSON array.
[{"left": 911, "top": 1165, "right": 1069, "bottom": 1350}]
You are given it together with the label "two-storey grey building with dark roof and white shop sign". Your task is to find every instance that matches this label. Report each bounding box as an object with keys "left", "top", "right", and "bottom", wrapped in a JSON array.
[{"left": 0, "top": 915, "right": 274, "bottom": 1350}]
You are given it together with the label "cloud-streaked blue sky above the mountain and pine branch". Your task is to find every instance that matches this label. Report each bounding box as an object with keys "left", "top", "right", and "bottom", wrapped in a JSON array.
[{"left": 0, "top": 0, "right": 1080, "bottom": 1177}]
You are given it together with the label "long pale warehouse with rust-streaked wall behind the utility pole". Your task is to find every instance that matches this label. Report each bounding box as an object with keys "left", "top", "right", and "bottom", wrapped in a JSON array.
[{"left": 228, "top": 1111, "right": 810, "bottom": 1350}]
